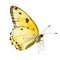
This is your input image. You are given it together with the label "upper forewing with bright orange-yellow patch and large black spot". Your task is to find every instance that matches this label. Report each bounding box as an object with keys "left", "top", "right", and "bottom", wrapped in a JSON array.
[{"left": 10, "top": 6, "right": 39, "bottom": 34}]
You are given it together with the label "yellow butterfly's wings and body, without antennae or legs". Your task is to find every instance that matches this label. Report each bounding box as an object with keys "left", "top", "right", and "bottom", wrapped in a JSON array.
[{"left": 10, "top": 6, "right": 46, "bottom": 50}]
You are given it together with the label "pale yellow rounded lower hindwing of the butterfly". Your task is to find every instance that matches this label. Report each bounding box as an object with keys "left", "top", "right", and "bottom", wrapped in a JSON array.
[{"left": 10, "top": 27, "right": 37, "bottom": 50}]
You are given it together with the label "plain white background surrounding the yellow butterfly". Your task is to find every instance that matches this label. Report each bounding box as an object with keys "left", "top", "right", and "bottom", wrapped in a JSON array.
[{"left": 0, "top": 0, "right": 60, "bottom": 60}]
